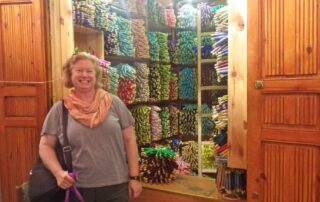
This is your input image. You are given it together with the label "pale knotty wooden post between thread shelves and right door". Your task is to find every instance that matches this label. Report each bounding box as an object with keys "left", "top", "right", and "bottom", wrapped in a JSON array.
[{"left": 228, "top": 0, "right": 247, "bottom": 169}]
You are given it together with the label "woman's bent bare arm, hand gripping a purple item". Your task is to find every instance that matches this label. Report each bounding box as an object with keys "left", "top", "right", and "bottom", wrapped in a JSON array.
[{"left": 39, "top": 134, "right": 74, "bottom": 189}]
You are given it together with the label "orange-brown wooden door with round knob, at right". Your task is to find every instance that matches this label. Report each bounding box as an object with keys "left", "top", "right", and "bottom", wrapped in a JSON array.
[{"left": 247, "top": 0, "right": 320, "bottom": 202}]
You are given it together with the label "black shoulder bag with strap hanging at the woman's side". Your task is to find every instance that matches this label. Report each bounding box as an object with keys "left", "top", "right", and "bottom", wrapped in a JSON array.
[{"left": 28, "top": 101, "right": 72, "bottom": 202}]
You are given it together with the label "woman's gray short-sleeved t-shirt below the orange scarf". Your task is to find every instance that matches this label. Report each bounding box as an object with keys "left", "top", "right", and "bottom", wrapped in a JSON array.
[{"left": 41, "top": 95, "right": 133, "bottom": 188}]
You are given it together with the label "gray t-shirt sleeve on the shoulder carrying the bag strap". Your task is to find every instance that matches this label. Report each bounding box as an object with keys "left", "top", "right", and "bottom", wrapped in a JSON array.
[{"left": 41, "top": 101, "right": 62, "bottom": 136}]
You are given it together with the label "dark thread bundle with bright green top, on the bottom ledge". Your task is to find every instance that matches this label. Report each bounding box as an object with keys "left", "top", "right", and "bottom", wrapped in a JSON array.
[{"left": 140, "top": 146, "right": 178, "bottom": 184}]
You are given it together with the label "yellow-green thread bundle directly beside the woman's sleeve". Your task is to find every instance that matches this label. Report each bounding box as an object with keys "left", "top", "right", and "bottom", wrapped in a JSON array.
[{"left": 130, "top": 105, "right": 151, "bottom": 145}]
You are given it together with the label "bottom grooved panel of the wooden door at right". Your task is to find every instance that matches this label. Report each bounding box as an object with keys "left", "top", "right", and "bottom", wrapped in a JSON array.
[{"left": 262, "top": 142, "right": 320, "bottom": 202}]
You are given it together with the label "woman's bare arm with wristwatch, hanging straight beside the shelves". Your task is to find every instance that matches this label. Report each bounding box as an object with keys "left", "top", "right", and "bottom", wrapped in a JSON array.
[{"left": 122, "top": 126, "right": 142, "bottom": 198}]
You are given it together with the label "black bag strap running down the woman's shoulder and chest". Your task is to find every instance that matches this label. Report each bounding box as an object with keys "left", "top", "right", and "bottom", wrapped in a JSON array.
[{"left": 62, "top": 100, "right": 73, "bottom": 173}]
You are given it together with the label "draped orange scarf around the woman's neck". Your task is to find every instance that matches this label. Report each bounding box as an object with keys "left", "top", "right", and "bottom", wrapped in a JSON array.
[{"left": 64, "top": 89, "right": 112, "bottom": 128}]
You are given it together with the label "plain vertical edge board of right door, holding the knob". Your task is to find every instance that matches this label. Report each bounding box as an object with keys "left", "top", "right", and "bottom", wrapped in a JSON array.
[{"left": 247, "top": 0, "right": 262, "bottom": 202}]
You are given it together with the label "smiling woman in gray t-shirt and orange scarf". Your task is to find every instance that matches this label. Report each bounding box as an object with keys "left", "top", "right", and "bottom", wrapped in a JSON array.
[{"left": 39, "top": 53, "right": 142, "bottom": 202}]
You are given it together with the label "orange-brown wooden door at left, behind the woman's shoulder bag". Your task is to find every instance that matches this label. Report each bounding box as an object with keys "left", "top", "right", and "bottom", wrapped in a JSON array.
[{"left": 0, "top": 0, "right": 48, "bottom": 202}]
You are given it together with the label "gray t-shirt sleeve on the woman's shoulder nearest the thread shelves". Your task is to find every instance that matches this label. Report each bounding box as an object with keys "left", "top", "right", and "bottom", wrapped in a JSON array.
[{"left": 112, "top": 95, "right": 134, "bottom": 129}]
